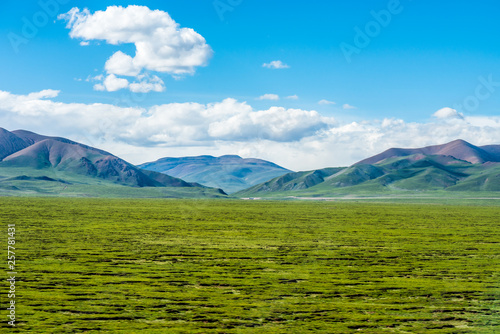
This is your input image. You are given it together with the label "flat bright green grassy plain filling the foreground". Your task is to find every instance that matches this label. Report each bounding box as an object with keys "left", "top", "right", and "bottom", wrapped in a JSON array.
[{"left": 0, "top": 198, "right": 500, "bottom": 333}]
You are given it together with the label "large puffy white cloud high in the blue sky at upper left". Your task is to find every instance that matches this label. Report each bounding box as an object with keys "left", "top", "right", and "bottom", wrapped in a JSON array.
[{"left": 59, "top": 6, "right": 212, "bottom": 92}]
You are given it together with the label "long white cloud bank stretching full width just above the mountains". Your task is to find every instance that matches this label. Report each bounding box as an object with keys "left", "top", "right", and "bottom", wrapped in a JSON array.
[{"left": 0, "top": 90, "right": 500, "bottom": 170}]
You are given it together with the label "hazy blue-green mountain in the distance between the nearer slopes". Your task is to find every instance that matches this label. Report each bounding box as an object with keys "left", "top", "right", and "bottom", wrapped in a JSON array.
[{"left": 138, "top": 155, "right": 290, "bottom": 193}]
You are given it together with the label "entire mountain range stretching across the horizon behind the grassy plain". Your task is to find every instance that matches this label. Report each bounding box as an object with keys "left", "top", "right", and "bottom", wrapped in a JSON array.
[{"left": 0, "top": 128, "right": 500, "bottom": 198}]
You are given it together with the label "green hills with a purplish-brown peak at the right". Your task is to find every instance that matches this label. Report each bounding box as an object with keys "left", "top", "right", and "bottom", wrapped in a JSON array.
[{"left": 235, "top": 140, "right": 500, "bottom": 197}]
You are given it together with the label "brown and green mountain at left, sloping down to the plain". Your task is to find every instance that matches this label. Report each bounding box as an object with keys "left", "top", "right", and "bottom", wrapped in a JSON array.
[{"left": 0, "top": 128, "right": 225, "bottom": 197}]
